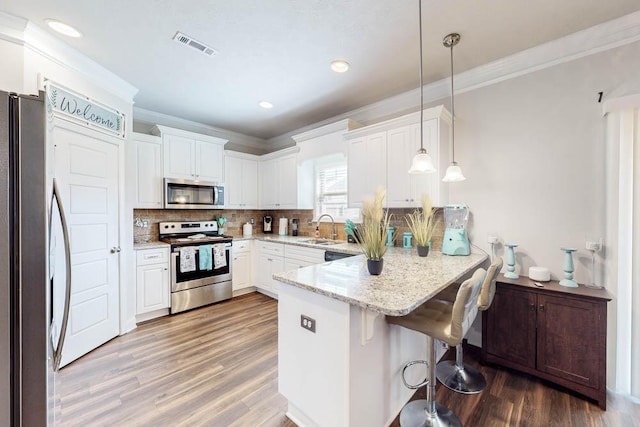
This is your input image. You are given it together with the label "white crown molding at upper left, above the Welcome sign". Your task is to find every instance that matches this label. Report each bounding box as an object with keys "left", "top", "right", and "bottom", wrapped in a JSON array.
[{"left": 0, "top": 12, "right": 138, "bottom": 104}]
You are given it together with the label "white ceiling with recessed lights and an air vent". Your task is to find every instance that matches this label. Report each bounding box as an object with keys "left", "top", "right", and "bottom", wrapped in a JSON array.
[{"left": 2, "top": 0, "right": 640, "bottom": 139}]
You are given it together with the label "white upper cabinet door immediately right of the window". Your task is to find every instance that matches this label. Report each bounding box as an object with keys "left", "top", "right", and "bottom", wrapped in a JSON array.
[{"left": 347, "top": 132, "right": 387, "bottom": 208}]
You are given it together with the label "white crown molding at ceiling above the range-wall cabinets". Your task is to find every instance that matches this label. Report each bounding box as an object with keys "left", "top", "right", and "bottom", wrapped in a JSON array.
[{"left": 133, "top": 106, "right": 267, "bottom": 152}]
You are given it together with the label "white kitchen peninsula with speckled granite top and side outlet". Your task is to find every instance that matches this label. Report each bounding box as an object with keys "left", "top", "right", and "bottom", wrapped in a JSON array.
[{"left": 274, "top": 248, "right": 487, "bottom": 427}]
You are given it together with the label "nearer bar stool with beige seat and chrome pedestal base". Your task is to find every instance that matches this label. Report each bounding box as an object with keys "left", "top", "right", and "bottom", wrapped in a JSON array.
[{"left": 387, "top": 268, "right": 486, "bottom": 427}]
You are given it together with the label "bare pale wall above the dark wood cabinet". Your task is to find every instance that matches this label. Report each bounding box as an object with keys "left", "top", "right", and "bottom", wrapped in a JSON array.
[{"left": 450, "top": 43, "right": 640, "bottom": 285}]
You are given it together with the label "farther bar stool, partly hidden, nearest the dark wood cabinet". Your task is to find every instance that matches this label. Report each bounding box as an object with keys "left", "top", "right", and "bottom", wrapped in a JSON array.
[{"left": 435, "top": 257, "right": 502, "bottom": 394}]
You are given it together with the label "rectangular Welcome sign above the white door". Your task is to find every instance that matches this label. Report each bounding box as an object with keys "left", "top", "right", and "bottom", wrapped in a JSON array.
[{"left": 47, "top": 82, "right": 124, "bottom": 138}]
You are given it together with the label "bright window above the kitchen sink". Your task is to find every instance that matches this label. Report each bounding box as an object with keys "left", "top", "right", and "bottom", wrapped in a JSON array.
[{"left": 314, "top": 158, "right": 360, "bottom": 222}]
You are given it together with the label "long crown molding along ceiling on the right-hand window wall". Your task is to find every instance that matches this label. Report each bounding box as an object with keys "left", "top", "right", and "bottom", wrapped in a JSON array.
[{"left": 268, "top": 11, "right": 640, "bottom": 146}]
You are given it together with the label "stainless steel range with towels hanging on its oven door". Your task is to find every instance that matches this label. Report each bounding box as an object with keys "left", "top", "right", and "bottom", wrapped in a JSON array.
[{"left": 160, "top": 221, "right": 233, "bottom": 314}]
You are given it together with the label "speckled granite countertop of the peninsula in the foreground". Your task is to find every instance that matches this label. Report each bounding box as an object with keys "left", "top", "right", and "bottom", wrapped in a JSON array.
[{"left": 273, "top": 249, "right": 488, "bottom": 316}]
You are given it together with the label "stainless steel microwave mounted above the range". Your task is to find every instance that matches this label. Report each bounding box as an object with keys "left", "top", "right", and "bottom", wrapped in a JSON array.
[{"left": 164, "top": 178, "right": 224, "bottom": 209}]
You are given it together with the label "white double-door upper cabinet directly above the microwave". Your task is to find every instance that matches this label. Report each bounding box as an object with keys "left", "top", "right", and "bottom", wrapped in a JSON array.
[{"left": 152, "top": 126, "right": 227, "bottom": 183}]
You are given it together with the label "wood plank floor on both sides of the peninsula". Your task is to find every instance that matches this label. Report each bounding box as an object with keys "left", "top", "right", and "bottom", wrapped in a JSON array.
[{"left": 57, "top": 293, "right": 640, "bottom": 427}]
